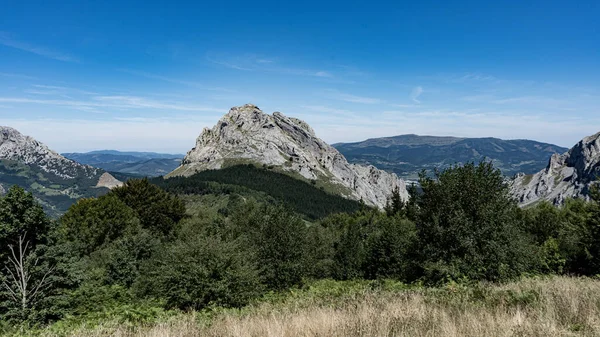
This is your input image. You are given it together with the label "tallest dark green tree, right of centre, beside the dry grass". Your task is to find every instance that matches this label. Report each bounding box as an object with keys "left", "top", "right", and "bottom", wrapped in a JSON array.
[{"left": 416, "top": 162, "right": 536, "bottom": 280}]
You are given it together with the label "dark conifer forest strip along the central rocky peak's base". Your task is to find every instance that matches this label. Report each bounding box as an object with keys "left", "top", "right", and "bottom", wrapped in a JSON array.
[{"left": 152, "top": 165, "right": 362, "bottom": 220}]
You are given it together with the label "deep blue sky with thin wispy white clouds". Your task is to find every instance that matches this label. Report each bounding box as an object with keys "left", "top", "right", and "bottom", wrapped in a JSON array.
[{"left": 0, "top": 0, "right": 600, "bottom": 152}]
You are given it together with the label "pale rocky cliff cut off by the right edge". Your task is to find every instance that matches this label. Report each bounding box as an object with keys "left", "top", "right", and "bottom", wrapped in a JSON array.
[{"left": 511, "top": 132, "right": 600, "bottom": 206}]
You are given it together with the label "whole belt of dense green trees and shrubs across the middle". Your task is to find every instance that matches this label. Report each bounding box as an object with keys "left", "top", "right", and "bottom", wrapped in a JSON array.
[{"left": 0, "top": 162, "right": 600, "bottom": 330}]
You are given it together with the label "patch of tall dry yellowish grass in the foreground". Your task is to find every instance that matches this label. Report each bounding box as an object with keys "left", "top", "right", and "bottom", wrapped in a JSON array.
[{"left": 39, "top": 277, "right": 600, "bottom": 337}]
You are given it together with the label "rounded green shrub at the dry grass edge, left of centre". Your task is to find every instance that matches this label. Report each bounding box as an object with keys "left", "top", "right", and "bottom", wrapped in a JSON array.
[{"left": 134, "top": 236, "right": 262, "bottom": 310}]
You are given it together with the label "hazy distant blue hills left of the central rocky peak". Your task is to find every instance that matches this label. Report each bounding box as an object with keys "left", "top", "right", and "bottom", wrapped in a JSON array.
[{"left": 62, "top": 150, "right": 184, "bottom": 177}]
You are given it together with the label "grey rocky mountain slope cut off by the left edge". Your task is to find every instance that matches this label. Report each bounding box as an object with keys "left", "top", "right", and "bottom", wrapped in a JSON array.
[{"left": 0, "top": 126, "right": 121, "bottom": 214}]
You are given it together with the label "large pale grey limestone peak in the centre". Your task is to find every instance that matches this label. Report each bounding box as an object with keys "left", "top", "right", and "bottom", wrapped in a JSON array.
[{"left": 168, "top": 104, "right": 408, "bottom": 207}]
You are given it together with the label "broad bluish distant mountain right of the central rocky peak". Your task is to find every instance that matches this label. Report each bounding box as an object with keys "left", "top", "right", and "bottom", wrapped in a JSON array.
[{"left": 333, "top": 134, "right": 568, "bottom": 179}]
